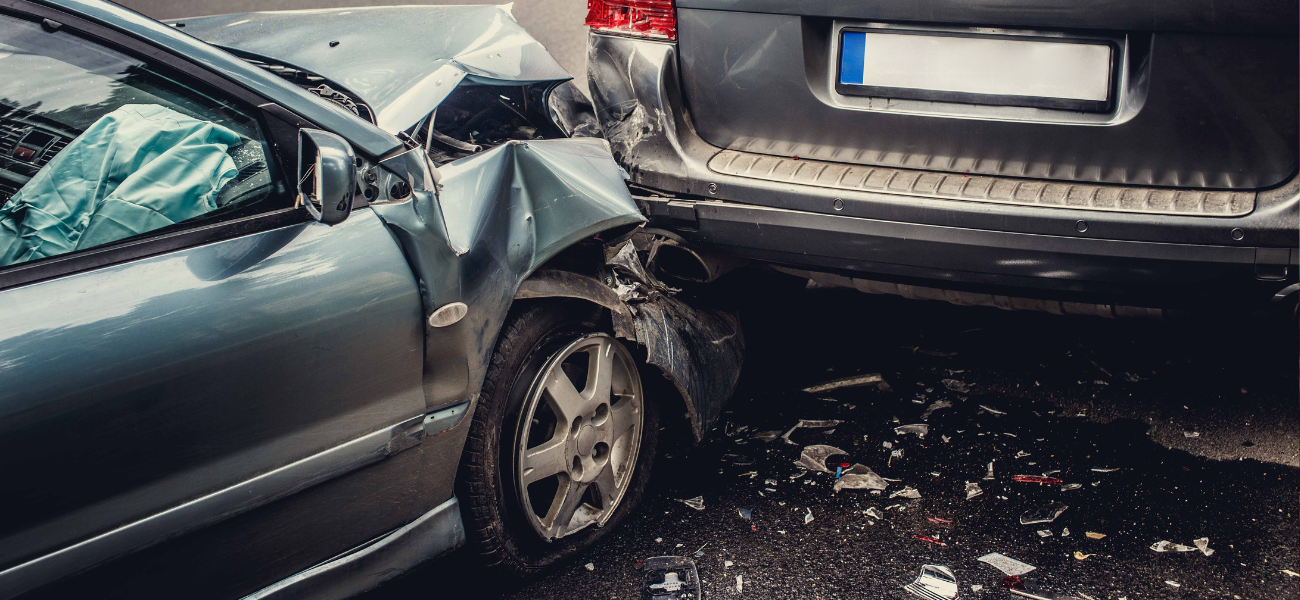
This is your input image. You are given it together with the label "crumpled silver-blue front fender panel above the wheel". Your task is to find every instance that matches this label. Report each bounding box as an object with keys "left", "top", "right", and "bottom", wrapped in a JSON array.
[{"left": 371, "top": 138, "right": 645, "bottom": 408}]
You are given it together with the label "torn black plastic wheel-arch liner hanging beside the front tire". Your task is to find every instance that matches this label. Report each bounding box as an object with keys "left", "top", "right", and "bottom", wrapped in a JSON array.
[{"left": 516, "top": 242, "right": 745, "bottom": 442}]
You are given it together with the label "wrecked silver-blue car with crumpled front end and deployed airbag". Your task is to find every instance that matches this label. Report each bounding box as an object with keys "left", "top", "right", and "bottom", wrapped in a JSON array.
[{"left": 0, "top": 0, "right": 742, "bottom": 599}]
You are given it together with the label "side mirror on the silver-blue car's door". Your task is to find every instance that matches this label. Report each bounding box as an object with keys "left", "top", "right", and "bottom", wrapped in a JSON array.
[{"left": 298, "top": 129, "right": 356, "bottom": 225}]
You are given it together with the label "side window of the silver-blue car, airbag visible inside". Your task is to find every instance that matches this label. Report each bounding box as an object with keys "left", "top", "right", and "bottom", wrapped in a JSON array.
[{"left": 0, "top": 14, "right": 287, "bottom": 269}]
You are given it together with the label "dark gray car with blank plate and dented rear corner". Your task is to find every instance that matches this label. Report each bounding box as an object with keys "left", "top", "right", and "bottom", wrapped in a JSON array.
[{"left": 588, "top": 0, "right": 1300, "bottom": 316}]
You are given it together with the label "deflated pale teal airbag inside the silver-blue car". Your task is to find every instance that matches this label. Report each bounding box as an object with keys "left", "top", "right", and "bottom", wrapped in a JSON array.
[{"left": 0, "top": 104, "right": 242, "bottom": 266}]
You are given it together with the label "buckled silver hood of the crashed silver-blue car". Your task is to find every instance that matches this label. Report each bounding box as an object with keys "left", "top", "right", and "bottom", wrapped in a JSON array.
[{"left": 172, "top": 4, "right": 572, "bottom": 134}]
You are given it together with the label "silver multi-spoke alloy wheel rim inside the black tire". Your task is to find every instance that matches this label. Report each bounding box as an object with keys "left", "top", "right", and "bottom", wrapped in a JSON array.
[{"left": 515, "top": 329, "right": 645, "bottom": 542}]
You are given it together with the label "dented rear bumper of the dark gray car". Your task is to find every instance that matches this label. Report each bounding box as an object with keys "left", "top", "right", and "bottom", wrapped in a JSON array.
[{"left": 588, "top": 34, "right": 1300, "bottom": 308}]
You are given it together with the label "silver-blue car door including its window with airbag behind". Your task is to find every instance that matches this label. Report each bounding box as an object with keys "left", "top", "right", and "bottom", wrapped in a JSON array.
[{"left": 0, "top": 12, "right": 424, "bottom": 597}]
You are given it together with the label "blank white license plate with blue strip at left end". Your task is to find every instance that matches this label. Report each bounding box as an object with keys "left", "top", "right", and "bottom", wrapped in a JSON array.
[{"left": 836, "top": 29, "right": 1115, "bottom": 110}]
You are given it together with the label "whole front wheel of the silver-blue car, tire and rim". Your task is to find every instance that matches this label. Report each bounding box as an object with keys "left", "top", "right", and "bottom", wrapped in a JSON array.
[{"left": 458, "top": 301, "right": 659, "bottom": 577}]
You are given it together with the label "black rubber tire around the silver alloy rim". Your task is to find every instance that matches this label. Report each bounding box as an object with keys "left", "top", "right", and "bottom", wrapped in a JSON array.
[{"left": 456, "top": 300, "right": 662, "bottom": 579}]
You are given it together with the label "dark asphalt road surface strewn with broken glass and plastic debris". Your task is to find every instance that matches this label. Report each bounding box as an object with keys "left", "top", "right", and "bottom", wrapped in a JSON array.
[{"left": 365, "top": 284, "right": 1300, "bottom": 600}]
